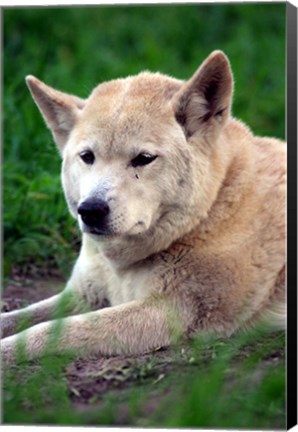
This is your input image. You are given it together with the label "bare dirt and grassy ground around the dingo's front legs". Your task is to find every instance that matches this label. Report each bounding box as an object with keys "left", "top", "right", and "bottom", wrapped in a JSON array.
[{"left": 2, "top": 272, "right": 285, "bottom": 427}]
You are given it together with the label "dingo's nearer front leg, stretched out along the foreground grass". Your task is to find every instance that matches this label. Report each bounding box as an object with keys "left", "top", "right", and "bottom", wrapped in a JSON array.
[{"left": 1, "top": 299, "right": 183, "bottom": 363}]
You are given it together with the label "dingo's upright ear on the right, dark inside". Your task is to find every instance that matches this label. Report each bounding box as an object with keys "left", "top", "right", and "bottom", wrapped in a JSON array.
[{"left": 175, "top": 51, "right": 233, "bottom": 139}]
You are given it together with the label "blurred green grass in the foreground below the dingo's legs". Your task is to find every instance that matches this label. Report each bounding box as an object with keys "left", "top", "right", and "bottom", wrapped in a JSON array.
[{"left": 3, "top": 332, "right": 285, "bottom": 429}]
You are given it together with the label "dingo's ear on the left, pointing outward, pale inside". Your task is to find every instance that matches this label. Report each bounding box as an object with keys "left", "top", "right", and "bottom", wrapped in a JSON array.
[{"left": 26, "top": 75, "right": 85, "bottom": 151}]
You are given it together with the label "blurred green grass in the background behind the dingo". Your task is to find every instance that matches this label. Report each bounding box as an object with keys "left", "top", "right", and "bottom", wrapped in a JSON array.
[{"left": 3, "top": 4, "right": 286, "bottom": 275}]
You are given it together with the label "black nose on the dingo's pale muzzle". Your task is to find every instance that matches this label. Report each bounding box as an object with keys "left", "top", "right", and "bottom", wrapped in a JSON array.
[{"left": 78, "top": 199, "right": 110, "bottom": 230}]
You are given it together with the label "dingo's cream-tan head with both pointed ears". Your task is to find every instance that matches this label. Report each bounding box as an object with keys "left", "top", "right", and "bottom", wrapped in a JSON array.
[{"left": 26, "top": 51, "right": 232, "bottom": 253}]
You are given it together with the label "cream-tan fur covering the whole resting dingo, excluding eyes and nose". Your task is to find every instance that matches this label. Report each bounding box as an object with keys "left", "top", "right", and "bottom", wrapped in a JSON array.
[{"left": 1, "top": 51, "right": 286, "bottom": 362}]
